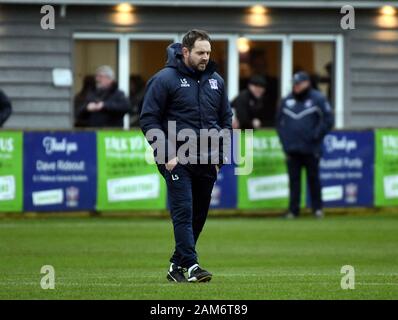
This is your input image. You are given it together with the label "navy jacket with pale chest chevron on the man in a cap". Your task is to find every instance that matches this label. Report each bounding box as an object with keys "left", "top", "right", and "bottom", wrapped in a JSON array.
[{"left": 276, "top": 89, "right": 333, "bottom": 154}]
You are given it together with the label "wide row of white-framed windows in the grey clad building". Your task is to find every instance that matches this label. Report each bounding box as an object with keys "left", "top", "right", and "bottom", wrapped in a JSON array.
[{"left": 74, "top": 33, "right": 344, "bottom": 128}]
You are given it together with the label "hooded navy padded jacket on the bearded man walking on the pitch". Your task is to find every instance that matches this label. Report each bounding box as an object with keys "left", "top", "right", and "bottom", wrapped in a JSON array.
[{"left": 140, "top": 43, "right": 232, "bottom": 163}]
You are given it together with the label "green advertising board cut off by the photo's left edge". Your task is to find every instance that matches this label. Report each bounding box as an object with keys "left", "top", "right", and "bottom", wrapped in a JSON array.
[{"left": 0, "top": 131, "right": 23, "bottom": 212}]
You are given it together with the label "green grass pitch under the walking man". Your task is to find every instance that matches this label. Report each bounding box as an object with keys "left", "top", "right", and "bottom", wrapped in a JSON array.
[{"left": 0, "top": 214, "right": 398, "bottom": 300}]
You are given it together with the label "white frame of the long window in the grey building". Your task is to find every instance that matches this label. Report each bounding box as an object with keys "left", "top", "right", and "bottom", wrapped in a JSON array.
[{"left": 73, "top": 32, "right": 344, "bottom": 129}]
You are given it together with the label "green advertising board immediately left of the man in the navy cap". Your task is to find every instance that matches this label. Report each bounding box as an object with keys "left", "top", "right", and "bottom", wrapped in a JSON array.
[{"left": 237, "top": 130, "right": 305, "bottom": 209}]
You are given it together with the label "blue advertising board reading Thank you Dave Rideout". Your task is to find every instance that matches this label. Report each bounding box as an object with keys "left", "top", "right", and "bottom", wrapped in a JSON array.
[{"left": 24, "top": 132, "right": 97, "bottom": 211}]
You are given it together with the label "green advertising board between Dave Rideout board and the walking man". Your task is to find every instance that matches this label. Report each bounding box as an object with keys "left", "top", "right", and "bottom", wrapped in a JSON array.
[{"left": 97, "top": 131, "right": 166, "bottom": 210}]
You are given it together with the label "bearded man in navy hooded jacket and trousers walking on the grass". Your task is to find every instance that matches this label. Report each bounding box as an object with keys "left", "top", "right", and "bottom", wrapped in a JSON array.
[{"left": 140, "top": 30, "right": 232, "bottom": 282}]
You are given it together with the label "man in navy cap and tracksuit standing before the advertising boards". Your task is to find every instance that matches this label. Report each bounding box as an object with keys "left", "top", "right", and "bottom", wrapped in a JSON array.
[{"left": 276, "top": 72, "right": 333, "bottom": 218}]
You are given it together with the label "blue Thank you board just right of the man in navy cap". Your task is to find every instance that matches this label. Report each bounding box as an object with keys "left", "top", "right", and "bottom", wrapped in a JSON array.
[{"left": 307, "top": 131, "right": 374, "bottom": 207}]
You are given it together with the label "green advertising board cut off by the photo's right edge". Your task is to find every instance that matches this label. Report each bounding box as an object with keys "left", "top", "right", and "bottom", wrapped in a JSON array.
[{"left": 375, "top": 129, "right": 398, "bottom": 207}]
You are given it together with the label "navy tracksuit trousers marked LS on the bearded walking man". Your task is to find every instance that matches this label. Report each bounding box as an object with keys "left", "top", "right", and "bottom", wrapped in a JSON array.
[{"left": 158, "top": 163, "right": 217, "bottom": 268}]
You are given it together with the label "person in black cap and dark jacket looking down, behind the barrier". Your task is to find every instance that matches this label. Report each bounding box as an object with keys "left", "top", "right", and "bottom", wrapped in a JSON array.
[{"left": 232, "top": 75, "right": 267, "bottom": 129}]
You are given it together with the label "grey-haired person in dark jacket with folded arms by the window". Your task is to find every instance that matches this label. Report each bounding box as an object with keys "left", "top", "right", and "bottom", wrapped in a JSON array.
[{"left": 77, "top": 66, "right": 131, "bottom": 128}]
